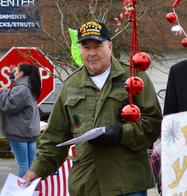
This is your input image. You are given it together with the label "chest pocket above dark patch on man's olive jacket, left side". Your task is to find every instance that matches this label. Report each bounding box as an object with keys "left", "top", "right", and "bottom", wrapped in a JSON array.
[{"left": 65, "top": 95, "right": 86, "bottom": 133}]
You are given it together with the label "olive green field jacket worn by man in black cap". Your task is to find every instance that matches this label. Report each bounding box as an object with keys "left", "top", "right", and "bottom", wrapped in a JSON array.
[{"left": 31, "top": 56, "right": 162, "bottom": 196}]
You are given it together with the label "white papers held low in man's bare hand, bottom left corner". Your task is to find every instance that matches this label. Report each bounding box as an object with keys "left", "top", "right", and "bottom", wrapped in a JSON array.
[{"left": 0, "top": 173, "right": 41, "bottom": 196}]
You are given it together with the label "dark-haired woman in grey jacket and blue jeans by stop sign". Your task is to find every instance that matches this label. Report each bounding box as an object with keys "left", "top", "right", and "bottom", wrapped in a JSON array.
[{"left": 0, "top": 63, "right": 41, "bottom": 177}]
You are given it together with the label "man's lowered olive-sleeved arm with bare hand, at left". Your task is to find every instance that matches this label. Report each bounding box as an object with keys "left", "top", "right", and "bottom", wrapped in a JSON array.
[{"left": 25, "top": 87, "right": 72, "bottom": 182}]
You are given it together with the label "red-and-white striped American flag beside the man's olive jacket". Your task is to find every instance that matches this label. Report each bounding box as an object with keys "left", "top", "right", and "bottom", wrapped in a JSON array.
[{"left": 39, "top": 146, "right": 75, "bottom": 196}]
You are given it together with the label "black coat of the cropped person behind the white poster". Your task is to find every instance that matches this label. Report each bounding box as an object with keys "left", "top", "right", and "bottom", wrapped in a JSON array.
[{"left": 164, "top": 60, "right": 187, "bottom": 115}]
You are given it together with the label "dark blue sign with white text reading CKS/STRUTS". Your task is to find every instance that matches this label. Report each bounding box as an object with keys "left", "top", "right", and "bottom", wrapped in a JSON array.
[{"left": 0, "top": 0, "right": 40, "bottom": 32}]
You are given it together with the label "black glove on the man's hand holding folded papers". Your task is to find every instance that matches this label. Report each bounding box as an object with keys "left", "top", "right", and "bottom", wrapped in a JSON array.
[{"left": 89, "top": 125, "right": 123, "bottom": 146}]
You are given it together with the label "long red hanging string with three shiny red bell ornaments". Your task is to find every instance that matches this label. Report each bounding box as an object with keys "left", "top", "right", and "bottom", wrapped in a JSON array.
[{"left": 114, "top": 0, "right": 151, "bottom": 123}]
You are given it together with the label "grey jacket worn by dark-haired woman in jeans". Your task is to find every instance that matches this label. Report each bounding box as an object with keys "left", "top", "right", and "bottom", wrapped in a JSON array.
[{"left": 0, "top": 76, "right": 40, "bottom": 141}]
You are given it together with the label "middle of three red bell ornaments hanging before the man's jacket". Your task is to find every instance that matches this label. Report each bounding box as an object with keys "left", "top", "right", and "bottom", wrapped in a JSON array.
[{"left": 125, "top": 77, "right": 144, "bottom": 95}]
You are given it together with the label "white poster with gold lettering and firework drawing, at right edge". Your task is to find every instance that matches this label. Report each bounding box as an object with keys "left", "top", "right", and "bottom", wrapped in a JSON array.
[{"left": 161, "top": 112, "right": 187, "bottom": 196}]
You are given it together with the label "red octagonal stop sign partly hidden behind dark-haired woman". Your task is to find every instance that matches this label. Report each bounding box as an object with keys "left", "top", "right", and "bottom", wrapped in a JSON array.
[{"left": 0, "top": 47, "right": 55, "bottom": 104}]
